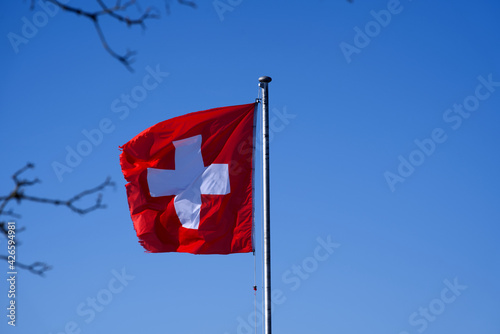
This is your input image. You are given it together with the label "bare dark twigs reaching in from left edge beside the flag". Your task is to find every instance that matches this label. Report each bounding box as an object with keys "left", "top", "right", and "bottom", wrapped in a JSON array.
[{"left": 0, "top": 163, "right": 114, "bottom": 276}]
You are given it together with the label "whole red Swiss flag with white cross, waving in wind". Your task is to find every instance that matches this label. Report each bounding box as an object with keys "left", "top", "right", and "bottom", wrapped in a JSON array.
[{"left": 120, "top": 103, "right": 256, "bottom": 254}]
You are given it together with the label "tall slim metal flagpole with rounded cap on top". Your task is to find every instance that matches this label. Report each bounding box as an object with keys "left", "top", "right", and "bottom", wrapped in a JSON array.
[{"left": 259, "top": 76, "right": 272, "bottom": 334}]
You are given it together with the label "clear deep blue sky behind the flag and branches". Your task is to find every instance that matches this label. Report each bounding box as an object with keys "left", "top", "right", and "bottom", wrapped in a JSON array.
[{"left": 0, "top": 0, "right": 500, "bottom": 334}]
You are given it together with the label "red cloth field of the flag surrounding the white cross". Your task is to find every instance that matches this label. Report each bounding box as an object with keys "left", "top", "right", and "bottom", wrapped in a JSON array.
[{"left": 120, "top": 103, "right": 255, "bottom": 254}]
